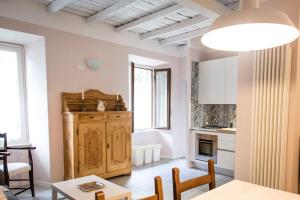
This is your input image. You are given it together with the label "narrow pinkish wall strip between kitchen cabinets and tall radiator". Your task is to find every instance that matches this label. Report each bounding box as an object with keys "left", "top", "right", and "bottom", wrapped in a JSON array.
[{"left": 234, "top": 53, "right": 253, "bottom": 181}]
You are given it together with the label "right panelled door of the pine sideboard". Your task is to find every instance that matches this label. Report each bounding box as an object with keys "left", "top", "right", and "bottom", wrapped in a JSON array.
[{"left": 106, "top": 121, "right": 131, "bottom": 172}]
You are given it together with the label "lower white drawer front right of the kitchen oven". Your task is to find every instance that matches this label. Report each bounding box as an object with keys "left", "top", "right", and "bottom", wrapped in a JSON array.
[{"left": 217, "top": 150, "right": 234, "bottom": 170}]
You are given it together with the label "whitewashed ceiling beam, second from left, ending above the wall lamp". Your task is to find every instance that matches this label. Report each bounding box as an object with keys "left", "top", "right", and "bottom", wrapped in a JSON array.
[{"left": 87, "top": 0, "right": 140, "bottom": 23}]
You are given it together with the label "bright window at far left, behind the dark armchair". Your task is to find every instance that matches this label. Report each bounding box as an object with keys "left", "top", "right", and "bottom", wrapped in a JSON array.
[{"left": 0, "top": 43, "right": 28, "bottom": 144}]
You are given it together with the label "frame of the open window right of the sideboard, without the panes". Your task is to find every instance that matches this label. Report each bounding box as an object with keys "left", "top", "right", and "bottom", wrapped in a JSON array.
[{"left": 130, "top": 62, "right": 171, "bottom": 132}]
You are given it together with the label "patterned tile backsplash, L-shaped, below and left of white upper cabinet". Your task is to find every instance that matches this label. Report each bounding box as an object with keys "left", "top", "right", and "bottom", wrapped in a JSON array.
[{"left": 191, "top": 62, "right": 236, "bottom": 128}]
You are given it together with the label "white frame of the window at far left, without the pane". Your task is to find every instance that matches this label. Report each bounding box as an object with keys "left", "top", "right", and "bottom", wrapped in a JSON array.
[{"left": 0, "top": 41, "right": 29, "bottom": 145}]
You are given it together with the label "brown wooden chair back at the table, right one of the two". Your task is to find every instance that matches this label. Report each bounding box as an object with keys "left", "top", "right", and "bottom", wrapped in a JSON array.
[{"left": 172, "top": 160, "right": 216, "bottom": 200}]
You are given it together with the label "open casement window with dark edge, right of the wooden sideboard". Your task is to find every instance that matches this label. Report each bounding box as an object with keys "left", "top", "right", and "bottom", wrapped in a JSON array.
[{"left": 132, "top": 63, "right": 171, "bottom": 130}]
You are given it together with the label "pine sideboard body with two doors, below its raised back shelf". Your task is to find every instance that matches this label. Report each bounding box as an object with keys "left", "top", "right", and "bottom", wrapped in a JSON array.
[{"left": 63, "top": 89, "right": 132, "bottom": 179}]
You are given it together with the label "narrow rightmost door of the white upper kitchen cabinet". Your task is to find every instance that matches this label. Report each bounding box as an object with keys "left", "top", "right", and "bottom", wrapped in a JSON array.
[{"left": 225, "top": 57, "right": 238, "bottom": 104}]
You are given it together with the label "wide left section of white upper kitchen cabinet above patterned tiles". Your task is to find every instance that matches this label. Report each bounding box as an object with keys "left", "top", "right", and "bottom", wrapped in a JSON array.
[{"left": 198, "top": 59, "right": 226, "bottom": 104}]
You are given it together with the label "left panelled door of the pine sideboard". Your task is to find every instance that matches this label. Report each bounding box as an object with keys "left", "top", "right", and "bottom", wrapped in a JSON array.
[{"left": 78, "top": 123, "right": 106, "bottom": 176}]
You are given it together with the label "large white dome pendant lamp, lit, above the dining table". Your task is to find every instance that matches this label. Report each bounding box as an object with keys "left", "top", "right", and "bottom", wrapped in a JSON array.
[{"left": 201, "top": 0, "right": 299, "bottom": 51}]
